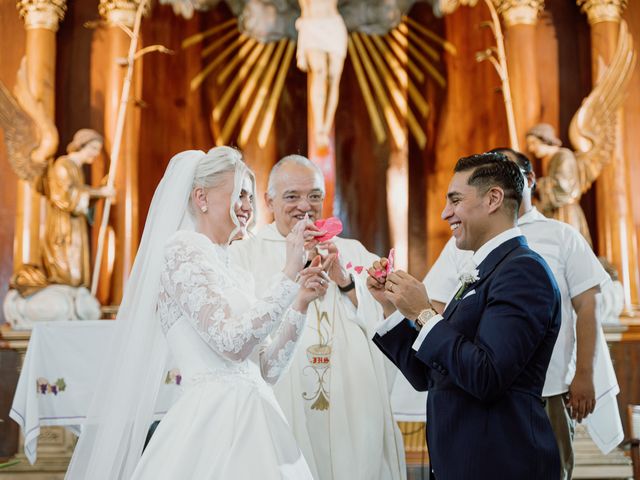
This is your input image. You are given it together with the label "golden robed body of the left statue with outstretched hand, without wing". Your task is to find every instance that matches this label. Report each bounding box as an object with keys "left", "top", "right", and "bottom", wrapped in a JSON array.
[{"left": 42, "top": 129, "right": 115, "bottom": 287}]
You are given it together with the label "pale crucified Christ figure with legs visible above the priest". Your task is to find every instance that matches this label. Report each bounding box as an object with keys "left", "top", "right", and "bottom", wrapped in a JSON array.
[{"left": 296, "top": 0, "right": 348, "bottom": 149}]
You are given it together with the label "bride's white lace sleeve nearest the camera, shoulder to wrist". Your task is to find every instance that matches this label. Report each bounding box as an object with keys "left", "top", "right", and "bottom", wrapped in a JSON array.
[{"left": 159, "top": 238, "right": 299, "bottom": 361}]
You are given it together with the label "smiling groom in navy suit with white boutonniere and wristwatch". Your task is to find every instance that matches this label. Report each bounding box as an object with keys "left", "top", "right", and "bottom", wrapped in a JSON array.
[{"left": 367, "top": 153, "right": 560, "bottom": 480}]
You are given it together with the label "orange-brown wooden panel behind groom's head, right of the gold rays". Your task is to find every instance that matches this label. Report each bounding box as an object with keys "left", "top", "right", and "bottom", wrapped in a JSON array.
[{"left": 426, "top": 2, "right": 509, "bottom": 265}]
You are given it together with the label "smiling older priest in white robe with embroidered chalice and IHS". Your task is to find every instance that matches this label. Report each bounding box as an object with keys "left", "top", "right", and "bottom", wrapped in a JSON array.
[{"left": 231, "top": 155, "right": 406, "bottom": 480}]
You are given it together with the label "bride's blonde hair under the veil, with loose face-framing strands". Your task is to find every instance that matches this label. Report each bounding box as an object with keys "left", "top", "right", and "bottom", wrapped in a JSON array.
[{"left": 189, "top": 146, "right": 256, "bottom": 241}]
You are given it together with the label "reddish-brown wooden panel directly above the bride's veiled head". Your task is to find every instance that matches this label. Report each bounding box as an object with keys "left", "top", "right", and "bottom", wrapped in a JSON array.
[{"left": 139, "top": 4, "right": 213, "bottom": 234}]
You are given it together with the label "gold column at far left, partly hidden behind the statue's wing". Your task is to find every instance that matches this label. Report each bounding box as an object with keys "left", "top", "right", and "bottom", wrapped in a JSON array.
[{"left": 13, "top": 0, "right": 67, "bottom": 272}]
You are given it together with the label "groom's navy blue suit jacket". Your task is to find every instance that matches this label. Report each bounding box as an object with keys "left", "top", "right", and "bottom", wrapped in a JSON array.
[{"left": 374, "top": 236, "right": 560, "bottom": 480}]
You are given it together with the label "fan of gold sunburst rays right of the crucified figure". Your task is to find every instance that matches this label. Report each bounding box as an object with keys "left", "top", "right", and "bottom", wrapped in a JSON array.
[{"left": 349, "top": 17, "right": 455, "bottom": 148}]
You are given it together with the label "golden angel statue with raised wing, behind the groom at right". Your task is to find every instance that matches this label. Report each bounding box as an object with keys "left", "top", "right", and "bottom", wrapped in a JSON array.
[{"left": 527, "top": 21, "right": 636, "bottom": 248}]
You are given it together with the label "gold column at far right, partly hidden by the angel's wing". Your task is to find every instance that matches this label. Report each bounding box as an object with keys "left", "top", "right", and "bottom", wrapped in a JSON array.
[{"left": 578, "top": 0, "right": 639, "bottom": 311}]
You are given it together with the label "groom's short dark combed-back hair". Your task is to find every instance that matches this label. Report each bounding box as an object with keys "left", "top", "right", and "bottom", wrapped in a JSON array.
[{"left": 453, "top": 152, "right": 524, "bottom": 216}]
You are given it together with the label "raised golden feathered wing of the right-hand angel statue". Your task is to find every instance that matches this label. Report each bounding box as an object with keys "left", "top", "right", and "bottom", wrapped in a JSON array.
[{"left": 569, "top": 21, "right": 636, "bottom": 192}]
